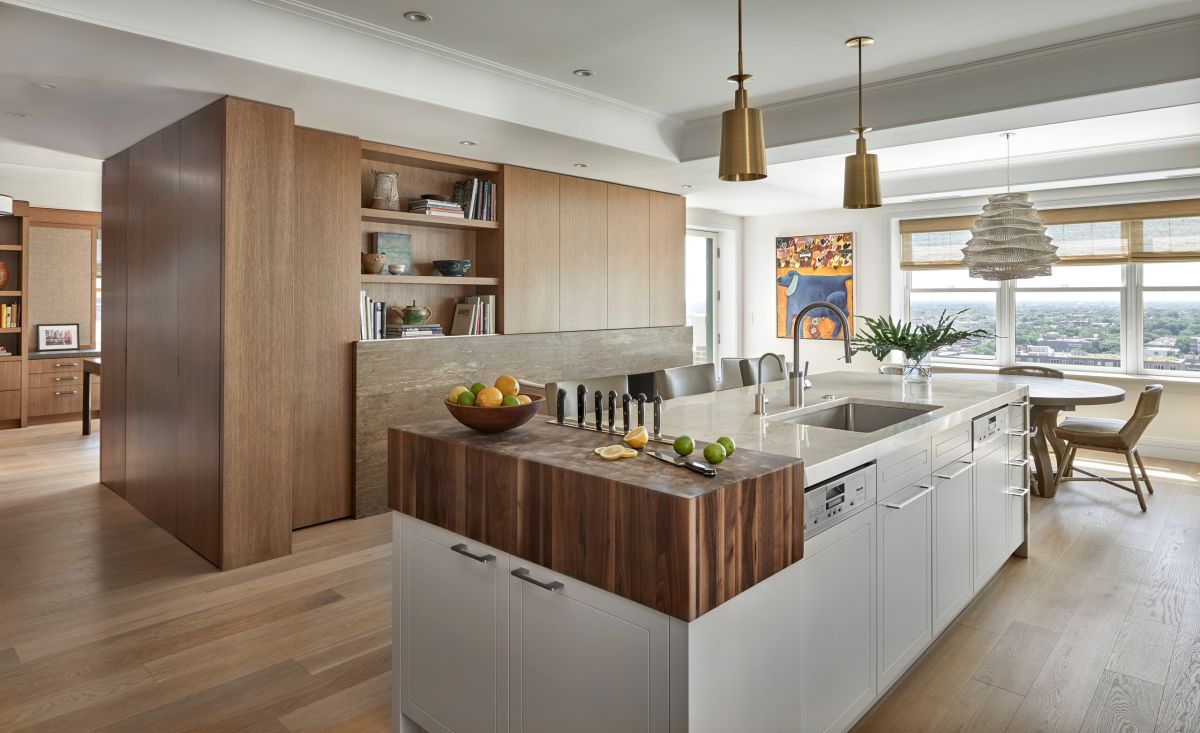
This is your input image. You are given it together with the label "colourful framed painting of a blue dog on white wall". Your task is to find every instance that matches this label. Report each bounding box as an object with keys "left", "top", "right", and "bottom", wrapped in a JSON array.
[{"left": 775, "top": 233, "right": 854, "bottom": 341}]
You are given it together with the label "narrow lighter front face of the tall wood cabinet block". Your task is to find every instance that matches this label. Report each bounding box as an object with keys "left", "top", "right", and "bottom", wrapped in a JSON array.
[{"left": 221, "top": 97, "right": 295, "bottom": 570}]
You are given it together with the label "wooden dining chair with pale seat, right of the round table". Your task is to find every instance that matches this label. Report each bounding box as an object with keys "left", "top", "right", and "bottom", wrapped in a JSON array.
[{"left": 1055, "top": 384, "right": 1163, "bottom": 511}]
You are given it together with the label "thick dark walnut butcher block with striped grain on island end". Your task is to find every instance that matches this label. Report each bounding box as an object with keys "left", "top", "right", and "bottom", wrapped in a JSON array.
[{"left": 388, "top": 416, "right": 804, "bottom": 621}]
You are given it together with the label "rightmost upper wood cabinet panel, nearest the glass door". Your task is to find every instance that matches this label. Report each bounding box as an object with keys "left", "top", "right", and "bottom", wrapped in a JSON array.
[{"left": 649, "top": 191, "right": 685, "bottom": 326}]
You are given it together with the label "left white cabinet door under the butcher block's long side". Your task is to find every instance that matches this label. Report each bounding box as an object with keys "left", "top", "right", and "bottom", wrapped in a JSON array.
[{"left": 392, "top": 515, "right": 509, "bottom": 733}]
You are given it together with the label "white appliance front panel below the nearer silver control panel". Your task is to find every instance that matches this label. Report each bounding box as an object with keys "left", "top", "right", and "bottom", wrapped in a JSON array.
[{"left": 797, "top": 509, "right": 877, "bottom": 733}]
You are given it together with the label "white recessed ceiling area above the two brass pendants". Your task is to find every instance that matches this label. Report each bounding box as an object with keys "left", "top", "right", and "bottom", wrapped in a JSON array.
[{"left": 274, "top": 0, "right": 1196, "bottom": 119}]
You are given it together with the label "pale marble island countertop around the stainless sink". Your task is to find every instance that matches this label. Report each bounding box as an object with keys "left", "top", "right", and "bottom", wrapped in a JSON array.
[{"left": 662, "top": 372, "right": 1028, "bottom": 486}]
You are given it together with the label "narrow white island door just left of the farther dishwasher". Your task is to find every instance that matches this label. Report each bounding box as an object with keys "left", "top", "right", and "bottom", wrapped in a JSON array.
[{"left": 932, "top": 456, "right": 974, "bottom": 636}]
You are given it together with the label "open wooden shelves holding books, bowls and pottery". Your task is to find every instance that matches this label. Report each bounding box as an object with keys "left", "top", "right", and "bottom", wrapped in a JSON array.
[{"left": 359, "top": 140, "right": 504, "bottom": 334}]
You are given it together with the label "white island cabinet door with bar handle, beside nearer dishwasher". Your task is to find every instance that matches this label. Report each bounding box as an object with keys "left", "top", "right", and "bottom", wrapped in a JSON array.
[{"left": 877, "top": 482, "right": 934, "bottom": 689}]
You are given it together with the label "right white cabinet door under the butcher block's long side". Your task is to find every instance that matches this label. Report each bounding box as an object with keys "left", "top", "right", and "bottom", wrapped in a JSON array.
[{"left": 509, "top": 559, "right": 671, "bottom": 733}]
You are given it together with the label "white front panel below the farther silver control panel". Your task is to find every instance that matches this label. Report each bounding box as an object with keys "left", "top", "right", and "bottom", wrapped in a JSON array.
[{"left": 972, "top": 439, "right": 1009, "bottom": 593}]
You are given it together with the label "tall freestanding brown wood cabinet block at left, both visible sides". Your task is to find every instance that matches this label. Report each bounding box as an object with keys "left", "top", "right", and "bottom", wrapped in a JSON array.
[{"left": 101, "top": 97, "right": 295, "bottom": 569}]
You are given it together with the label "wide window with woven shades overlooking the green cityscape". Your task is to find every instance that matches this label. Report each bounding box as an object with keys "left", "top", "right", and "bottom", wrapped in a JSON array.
[{"left": 900, "top": 199, "right": 1200, "bottom": 377}]
